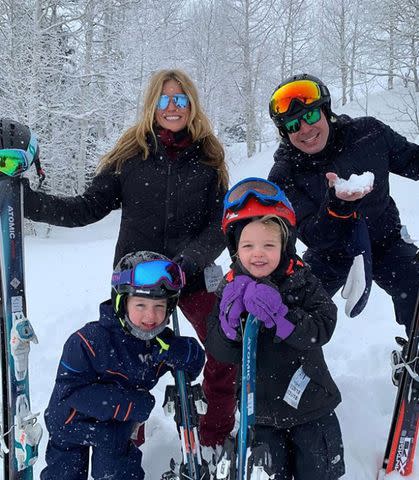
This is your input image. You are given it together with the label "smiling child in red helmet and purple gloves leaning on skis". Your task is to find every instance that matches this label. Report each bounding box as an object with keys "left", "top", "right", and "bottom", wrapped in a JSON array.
[{"left": 206, "top": 178, "right": 345, "bottom": 480}]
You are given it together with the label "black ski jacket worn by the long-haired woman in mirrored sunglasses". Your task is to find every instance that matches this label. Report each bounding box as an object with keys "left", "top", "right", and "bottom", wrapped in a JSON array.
[{"left": 24, "top": 135, "right": 225, "bottom": 278}]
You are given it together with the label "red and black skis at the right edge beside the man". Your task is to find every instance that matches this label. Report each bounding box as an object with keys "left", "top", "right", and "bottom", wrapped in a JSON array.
[{"left": 378, "top": 295, "right": 419, "bottom": 478}]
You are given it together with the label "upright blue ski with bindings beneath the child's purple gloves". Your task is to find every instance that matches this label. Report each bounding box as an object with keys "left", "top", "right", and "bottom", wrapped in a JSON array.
[{"left": 216, "top": 314, "right": 274, "bottom": 480}]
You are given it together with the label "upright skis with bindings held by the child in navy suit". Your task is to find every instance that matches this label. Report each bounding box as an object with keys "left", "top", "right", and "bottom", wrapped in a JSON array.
[{"left": 161, "top": 309, "right": 210, "bottom": 480}]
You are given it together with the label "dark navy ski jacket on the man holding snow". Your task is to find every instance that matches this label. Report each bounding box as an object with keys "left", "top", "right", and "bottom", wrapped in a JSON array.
[{"left": 268, "top": 115, "right": 419, "bottom": 255}]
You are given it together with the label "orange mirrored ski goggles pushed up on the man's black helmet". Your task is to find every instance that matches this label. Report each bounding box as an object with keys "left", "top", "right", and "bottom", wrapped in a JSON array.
[{"left": 271, "top": 80, "right": 322, "bottom": 115}]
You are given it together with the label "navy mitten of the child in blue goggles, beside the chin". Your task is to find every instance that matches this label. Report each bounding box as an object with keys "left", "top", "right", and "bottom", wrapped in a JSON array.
[{"left": 152, "top": 337, "right": 205, "bottom": 380}]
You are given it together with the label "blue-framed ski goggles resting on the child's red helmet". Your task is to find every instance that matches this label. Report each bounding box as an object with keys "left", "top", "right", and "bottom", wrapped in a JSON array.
[{"left": 224, "top": 177, "right": 292, "bottom": 211}]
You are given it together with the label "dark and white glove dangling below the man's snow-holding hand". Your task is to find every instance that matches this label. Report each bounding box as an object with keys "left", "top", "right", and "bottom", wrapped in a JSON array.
[{"left": 342, "top": 219, "right": 372, "bottom": 317}]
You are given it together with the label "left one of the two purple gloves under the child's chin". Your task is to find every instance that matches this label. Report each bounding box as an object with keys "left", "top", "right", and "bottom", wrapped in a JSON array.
[{"left": 220, "top": 275, "right": 253, "bottom": 340}]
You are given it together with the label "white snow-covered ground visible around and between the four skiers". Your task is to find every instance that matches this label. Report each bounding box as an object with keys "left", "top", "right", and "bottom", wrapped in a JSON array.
[{"left": 19, "top": 89, "right": 419, "bottom": 480}]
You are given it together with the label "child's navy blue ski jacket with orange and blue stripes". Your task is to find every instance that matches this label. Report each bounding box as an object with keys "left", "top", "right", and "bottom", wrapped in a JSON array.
[{"left": 46, "top": 301, "right": 203, "bottom": 433}]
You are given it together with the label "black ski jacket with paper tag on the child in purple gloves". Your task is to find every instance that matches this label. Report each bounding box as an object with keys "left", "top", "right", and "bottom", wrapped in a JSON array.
[{"left": 205, "top": 262, "right": 341, "bottom": 428}]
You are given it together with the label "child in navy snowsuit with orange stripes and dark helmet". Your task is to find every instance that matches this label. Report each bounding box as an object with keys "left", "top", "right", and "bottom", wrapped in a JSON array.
[{"left": 41, "top": 251, "right": 205, "bottom": 480}]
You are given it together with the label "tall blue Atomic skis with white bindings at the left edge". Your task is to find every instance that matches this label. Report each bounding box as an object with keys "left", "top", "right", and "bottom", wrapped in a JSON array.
[{"left": 0, "top": 171, "right": 42, "bottom": 480}]
